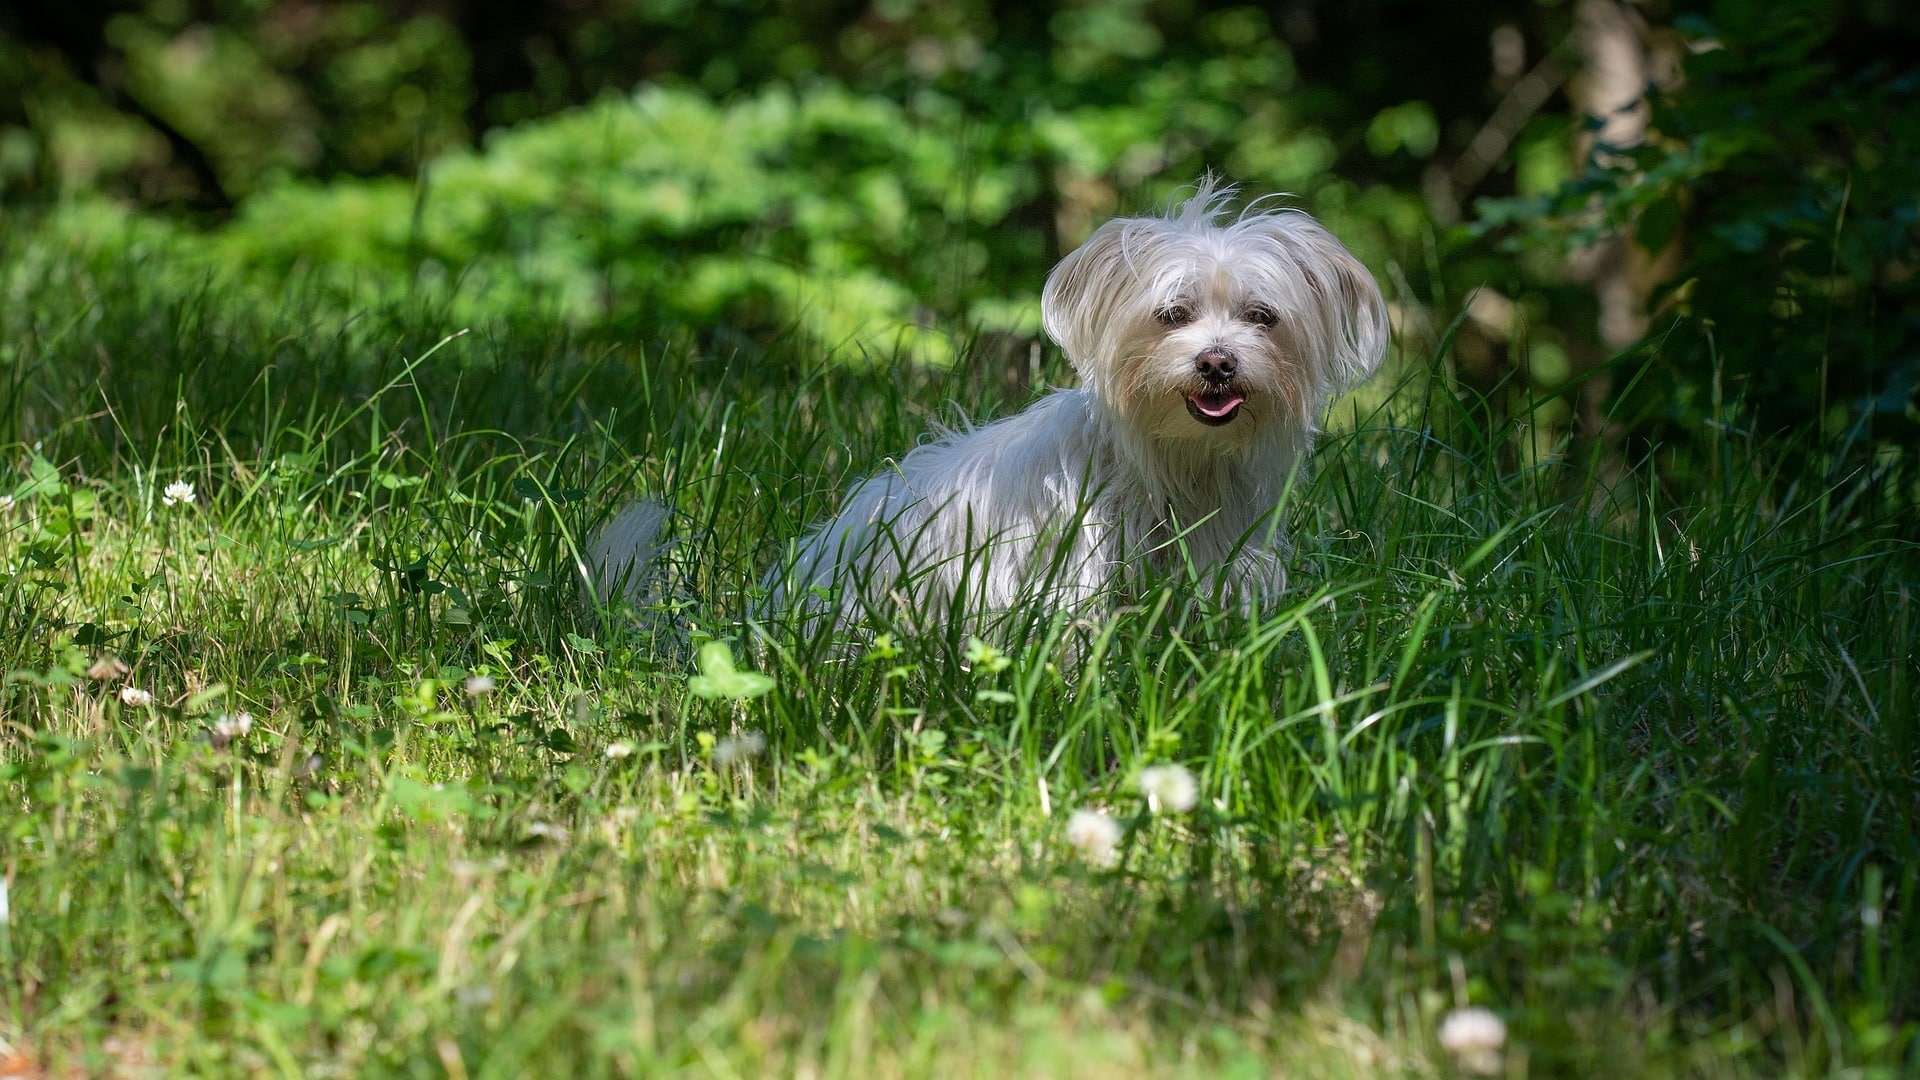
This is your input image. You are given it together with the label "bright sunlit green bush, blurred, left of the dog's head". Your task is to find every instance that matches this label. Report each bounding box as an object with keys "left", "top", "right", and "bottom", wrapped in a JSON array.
[{"left": 213, "top": 86, "right": 1037, "bottom": 359}]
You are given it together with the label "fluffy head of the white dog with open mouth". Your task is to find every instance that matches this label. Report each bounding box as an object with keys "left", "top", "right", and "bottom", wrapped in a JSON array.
[{"left": 1041, "top": 177, "right": 1388, "bottom": 446}]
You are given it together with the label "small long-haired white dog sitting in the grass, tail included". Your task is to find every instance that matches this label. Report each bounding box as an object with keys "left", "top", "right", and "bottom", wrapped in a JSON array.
[{"left": 589, "top": 179, "right": 1388, "bottom": 617}]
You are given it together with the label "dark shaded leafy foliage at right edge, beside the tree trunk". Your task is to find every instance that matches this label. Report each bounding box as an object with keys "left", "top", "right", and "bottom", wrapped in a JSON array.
[{"left": 1480, "top": 0, "right": 1920, "bottom": 463}]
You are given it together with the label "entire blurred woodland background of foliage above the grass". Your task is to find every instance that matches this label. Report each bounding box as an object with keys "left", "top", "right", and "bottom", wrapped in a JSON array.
[{"left": 0, "top": 0, "right": 1920, "bottom": 478}]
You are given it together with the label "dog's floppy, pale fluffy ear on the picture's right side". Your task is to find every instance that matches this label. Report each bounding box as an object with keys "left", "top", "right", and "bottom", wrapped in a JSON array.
[{"left": 1233, "top": 209, "right": 1392, "bottom": 405}]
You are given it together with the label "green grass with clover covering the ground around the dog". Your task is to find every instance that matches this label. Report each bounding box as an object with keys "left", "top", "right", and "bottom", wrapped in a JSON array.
[{"left": 0, "top": 228, "right": 1920, "bottom": 1076}]
